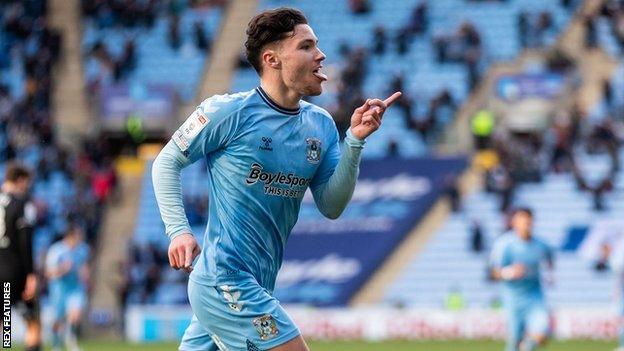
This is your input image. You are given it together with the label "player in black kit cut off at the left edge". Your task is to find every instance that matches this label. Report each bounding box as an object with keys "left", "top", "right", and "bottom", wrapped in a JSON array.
[{"left": 0, "top": 164, "right": 41, "bottom": 351}]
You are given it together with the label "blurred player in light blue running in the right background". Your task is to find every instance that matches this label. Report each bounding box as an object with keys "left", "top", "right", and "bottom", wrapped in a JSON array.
[{"left": 491, "top": 208, "right": 553, "bottom": 351}]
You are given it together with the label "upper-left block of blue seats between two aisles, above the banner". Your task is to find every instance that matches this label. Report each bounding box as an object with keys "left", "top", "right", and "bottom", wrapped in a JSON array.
[{"left": 82, "top": 1, "right": 223, "bottom": 101}]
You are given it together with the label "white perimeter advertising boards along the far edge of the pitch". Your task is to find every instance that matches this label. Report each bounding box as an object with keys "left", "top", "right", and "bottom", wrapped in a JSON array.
[{"left": 125, "top": 306, "right": 620, "bottom": 342}]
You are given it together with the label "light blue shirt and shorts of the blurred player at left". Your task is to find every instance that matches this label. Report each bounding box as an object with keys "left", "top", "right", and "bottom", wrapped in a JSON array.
[{"left": 46, "top": 240, "right": 90, "bottom": 319}]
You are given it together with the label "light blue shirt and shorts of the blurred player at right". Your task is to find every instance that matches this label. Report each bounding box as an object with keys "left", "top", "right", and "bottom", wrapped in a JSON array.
[{"left": 491, "top": 232, "right": 553, "bottom": 351}]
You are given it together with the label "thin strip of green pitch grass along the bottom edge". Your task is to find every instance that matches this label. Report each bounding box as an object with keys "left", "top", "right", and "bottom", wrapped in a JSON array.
[{"left": 46, "top": 340, "right": 616, "bottom": 351}]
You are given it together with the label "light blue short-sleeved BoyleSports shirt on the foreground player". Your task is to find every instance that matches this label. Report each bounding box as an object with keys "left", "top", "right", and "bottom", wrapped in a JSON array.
[{"left": 161, "top": 88, "right": 340, "bottom": 291}]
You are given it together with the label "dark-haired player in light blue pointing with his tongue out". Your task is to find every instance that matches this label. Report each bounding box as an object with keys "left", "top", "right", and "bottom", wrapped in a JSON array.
[{"left": 152, "top": 8, "right": 401, "bottom": 351}]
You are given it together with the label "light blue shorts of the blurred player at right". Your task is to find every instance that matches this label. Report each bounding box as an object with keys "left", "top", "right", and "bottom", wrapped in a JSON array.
[{"left": 507, "top": 300, "right": 551, "bottom": 351}]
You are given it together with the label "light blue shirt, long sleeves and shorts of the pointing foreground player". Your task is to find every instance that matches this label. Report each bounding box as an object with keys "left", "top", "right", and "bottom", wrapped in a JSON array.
[{"left": 152, "top": 88, "right": 365, "bottom": 350}]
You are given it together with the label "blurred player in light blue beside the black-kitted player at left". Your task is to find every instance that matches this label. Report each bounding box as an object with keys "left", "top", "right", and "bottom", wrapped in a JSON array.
[{"left": 46, "top": 223, "right": 89, "bottom": 351}]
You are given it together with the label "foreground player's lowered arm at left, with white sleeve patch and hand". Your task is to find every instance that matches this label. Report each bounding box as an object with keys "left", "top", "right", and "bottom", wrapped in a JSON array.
[{"left": 152, "top": 96, "right": 238, "bottom": 272}]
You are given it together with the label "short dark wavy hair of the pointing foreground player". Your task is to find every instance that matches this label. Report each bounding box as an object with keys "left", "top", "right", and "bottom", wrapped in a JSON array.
[{"left": 245, "top": 7, "right": 308, "bottom": 74}]
